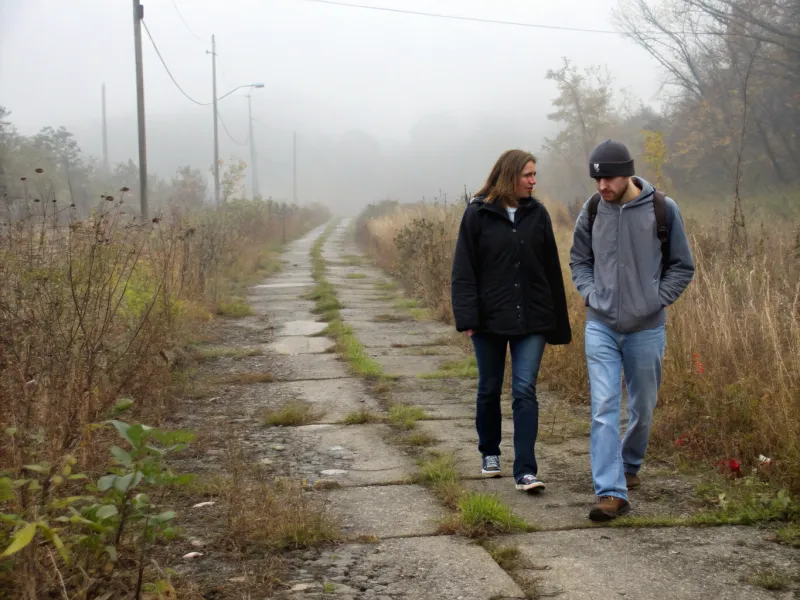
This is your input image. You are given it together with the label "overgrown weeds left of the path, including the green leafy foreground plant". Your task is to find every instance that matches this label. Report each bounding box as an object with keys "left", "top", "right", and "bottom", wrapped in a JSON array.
[{"left": 0, "top": 155, "right": 327, "bottom": 600}]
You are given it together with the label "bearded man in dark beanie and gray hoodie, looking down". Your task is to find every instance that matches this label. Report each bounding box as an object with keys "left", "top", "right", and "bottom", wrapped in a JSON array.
[{"left": 570, "top": 140, "right": 694, "bottom": 521}]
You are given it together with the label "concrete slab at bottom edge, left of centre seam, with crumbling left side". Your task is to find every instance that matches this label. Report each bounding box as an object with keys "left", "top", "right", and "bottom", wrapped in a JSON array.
[{"left": 350, "top": 536, "right": 526, "bottom": 600}]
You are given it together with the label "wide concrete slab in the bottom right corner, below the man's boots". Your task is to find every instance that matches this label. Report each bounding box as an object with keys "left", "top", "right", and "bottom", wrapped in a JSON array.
[{"left": 497, "top": 527, "right": 800, "bottom": 600}]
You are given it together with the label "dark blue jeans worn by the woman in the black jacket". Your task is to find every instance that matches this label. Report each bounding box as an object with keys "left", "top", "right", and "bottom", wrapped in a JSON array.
[{"left": 471, "top": 333, "right": 545, "bottom": 480}]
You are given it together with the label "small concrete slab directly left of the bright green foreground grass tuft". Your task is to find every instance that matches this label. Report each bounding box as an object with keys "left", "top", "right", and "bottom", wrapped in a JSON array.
[{"left": 327, "top": 485, "right": 448, "bottom": 539}]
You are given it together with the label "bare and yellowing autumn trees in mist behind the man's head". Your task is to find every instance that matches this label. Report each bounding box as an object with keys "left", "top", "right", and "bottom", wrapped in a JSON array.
[{"left": 545, "top": 0, "right": 800, "bottom": 207}]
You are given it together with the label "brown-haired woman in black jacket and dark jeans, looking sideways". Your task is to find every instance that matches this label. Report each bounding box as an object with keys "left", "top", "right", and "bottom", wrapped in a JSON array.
[{"left": 451, "top": 150, "right": 572, "bottom": 491}]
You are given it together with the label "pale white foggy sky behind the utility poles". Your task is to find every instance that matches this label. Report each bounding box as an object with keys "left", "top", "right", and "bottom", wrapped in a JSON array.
[{"left": 0, "top": 0, "right": 662, "bottom": 214}]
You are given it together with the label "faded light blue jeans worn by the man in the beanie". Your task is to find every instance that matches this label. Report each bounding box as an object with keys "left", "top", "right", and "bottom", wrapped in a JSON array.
[{"left": 585, "top": 321, "right": 667, "bottom": 500}]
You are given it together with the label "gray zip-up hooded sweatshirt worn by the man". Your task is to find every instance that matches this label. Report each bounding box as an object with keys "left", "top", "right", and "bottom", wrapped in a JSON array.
[{"left": 569, "top": 177, "right": 694, "bottom": 333}]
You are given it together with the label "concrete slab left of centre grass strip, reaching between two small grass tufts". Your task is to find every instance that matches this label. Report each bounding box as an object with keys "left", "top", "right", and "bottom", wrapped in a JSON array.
[{"left": 260, "top": 379, "right": 380, "bottom": 423}]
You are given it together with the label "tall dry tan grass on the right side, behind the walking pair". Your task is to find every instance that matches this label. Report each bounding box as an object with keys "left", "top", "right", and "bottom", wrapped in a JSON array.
[{"left": 357, "top": 201, "right": 800, "bottom": 491}]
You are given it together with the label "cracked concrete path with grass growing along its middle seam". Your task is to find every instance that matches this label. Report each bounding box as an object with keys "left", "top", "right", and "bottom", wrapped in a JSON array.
[{"left": 183, "top": 222, "right": 800, "bottom": 600}]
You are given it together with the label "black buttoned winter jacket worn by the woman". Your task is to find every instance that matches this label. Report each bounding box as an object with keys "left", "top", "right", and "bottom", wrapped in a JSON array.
[{"left": 450, "top": 197, "right": 572, "bottom": 344}]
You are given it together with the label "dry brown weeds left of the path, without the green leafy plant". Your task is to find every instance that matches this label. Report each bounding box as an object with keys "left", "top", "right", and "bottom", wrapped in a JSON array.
[{"left": 0, "top": 180, "right": 325, "bottom": 600}]
